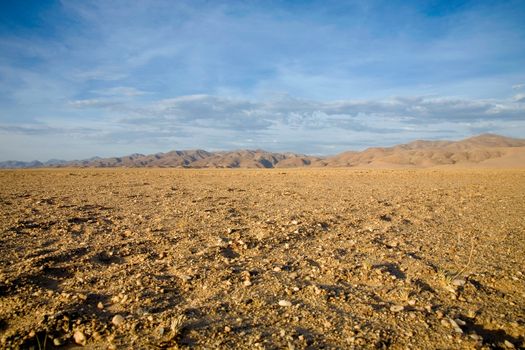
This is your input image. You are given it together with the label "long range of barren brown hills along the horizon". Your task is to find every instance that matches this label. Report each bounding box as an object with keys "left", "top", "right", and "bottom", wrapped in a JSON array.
[{"left": 0, "top": 134, "right": 525, "bottom": 168}]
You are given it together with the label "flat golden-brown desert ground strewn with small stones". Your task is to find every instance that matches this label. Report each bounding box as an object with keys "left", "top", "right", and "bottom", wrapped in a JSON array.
[{"left": 0, "top": 169, "right": 525, "bottom": 349}]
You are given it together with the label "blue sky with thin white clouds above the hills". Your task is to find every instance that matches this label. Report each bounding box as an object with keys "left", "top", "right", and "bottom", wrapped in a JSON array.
[{"left": 0, "top": 0, "right": 525, "bottom": 161}]
